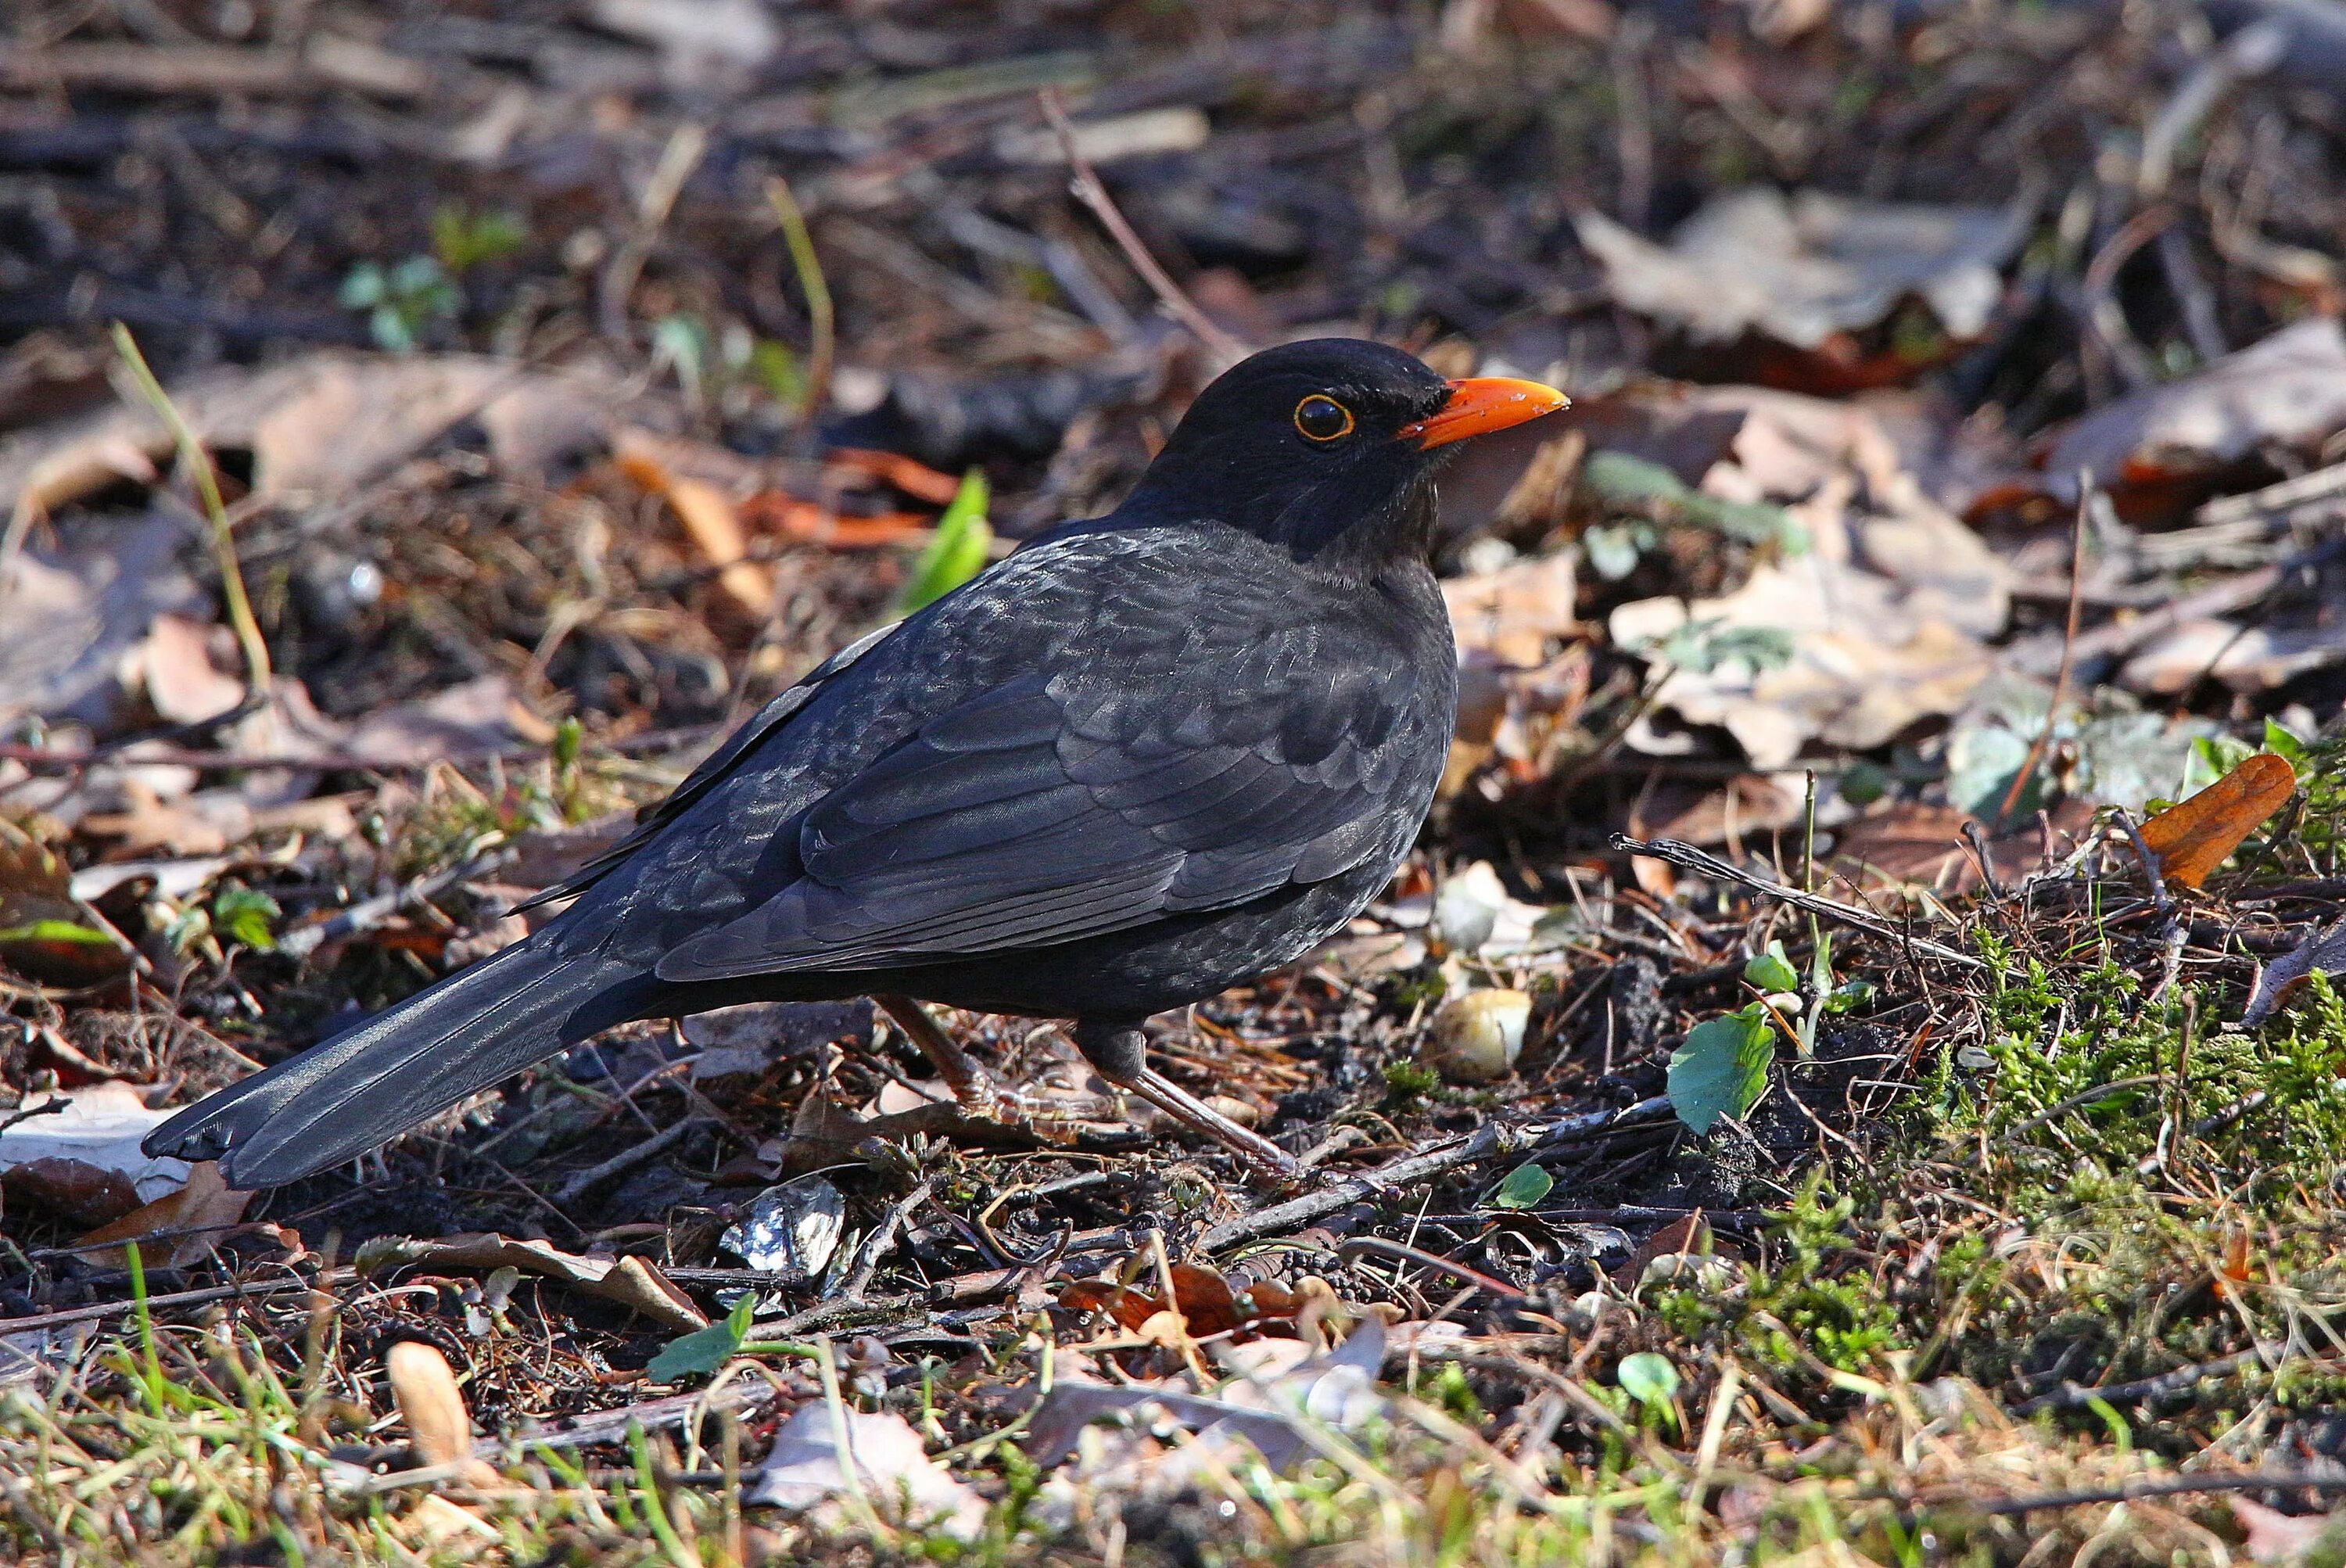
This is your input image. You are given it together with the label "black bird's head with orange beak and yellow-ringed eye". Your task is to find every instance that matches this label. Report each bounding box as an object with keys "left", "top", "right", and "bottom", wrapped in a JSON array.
[{"left": 1126, "top": 338, "right": 1567, "bottom": 558}]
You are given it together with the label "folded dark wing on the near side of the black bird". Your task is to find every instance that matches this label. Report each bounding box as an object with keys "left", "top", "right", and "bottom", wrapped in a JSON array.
[{"left": 659, "top": 617, "right": 1447, "bottom": 981}]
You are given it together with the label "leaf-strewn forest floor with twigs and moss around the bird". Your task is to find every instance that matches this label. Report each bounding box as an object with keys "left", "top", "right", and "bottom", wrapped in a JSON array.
[{"left": 0, "top": 0, "right": 2346, "bottom": 1568}]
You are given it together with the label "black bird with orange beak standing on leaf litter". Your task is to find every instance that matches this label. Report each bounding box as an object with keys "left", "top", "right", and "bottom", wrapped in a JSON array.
[{"left": 145, "top": 338, "right": 1565, "bottom": 1188}]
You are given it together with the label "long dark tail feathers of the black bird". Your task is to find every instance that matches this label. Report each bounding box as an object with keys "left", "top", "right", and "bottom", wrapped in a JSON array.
[{"left": 145, "top": 939, "right": 631, "bottom": 1188}]
